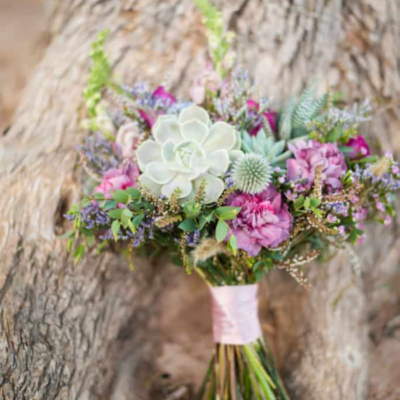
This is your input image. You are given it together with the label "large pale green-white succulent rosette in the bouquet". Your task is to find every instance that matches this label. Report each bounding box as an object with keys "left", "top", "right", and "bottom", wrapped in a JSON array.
[{"left": 136, "top": 106, "right": 242, "bottom": 203}]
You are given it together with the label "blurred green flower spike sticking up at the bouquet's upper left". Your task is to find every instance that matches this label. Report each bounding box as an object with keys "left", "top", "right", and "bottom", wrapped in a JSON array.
[{"left": 83, "top": 30, "right": 111, "bottom": 118}]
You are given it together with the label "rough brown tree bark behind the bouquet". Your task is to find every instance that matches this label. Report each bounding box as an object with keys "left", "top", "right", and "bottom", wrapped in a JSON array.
[{"left": 0, "top": 0, "right": 400, "bottom": 400}]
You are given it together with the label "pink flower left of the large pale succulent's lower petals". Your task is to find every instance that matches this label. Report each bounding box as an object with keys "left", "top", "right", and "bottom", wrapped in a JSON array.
[{"left": 93, "top": 164, "right": 139, "bottom": 199}]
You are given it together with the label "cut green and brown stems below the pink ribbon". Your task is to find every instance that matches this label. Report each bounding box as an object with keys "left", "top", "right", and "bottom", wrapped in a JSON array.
[{"left": 197, "top": 338, "right": 289, "bottom": 400}]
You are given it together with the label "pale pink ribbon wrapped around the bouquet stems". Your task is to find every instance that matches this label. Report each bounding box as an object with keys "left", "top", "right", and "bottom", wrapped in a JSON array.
[{"left": 210, "top": 284, "right": 261, "bottom": 345}]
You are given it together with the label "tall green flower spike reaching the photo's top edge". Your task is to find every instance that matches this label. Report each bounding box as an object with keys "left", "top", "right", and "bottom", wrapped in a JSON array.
[{"left": 194, "top": 0, "right": 234, "bottom": 78}]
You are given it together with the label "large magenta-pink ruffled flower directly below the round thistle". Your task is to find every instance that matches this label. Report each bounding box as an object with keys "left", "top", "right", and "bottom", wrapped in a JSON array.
[{"left": 227, "top": 185, "right": 293, "bottom": 256}]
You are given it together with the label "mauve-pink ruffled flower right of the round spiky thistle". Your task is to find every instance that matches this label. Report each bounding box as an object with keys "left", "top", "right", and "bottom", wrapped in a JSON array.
[{"left": 286, "top": 140, "right": 347, "bottom": 190}]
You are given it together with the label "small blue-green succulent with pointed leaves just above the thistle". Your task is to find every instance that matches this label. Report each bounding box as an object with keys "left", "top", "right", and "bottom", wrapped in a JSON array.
[{"left": 242, "top": 130, "right": 292, "bottom": 166}]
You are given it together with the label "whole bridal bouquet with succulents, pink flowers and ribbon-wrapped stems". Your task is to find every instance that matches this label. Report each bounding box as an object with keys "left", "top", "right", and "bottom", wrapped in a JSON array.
[{"left": 65, "top": 0, "right": 400, "bottom": 400}]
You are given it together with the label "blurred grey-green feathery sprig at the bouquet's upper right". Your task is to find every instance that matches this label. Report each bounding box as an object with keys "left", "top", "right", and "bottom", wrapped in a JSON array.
[{"left": 278, "top": 88, "right": 328, "bottom": 140}]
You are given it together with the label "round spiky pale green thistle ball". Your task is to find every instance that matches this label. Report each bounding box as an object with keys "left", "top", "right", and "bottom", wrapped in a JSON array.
[{"left": 232, "top": 154, "right": 272, "bottom": 194}]
